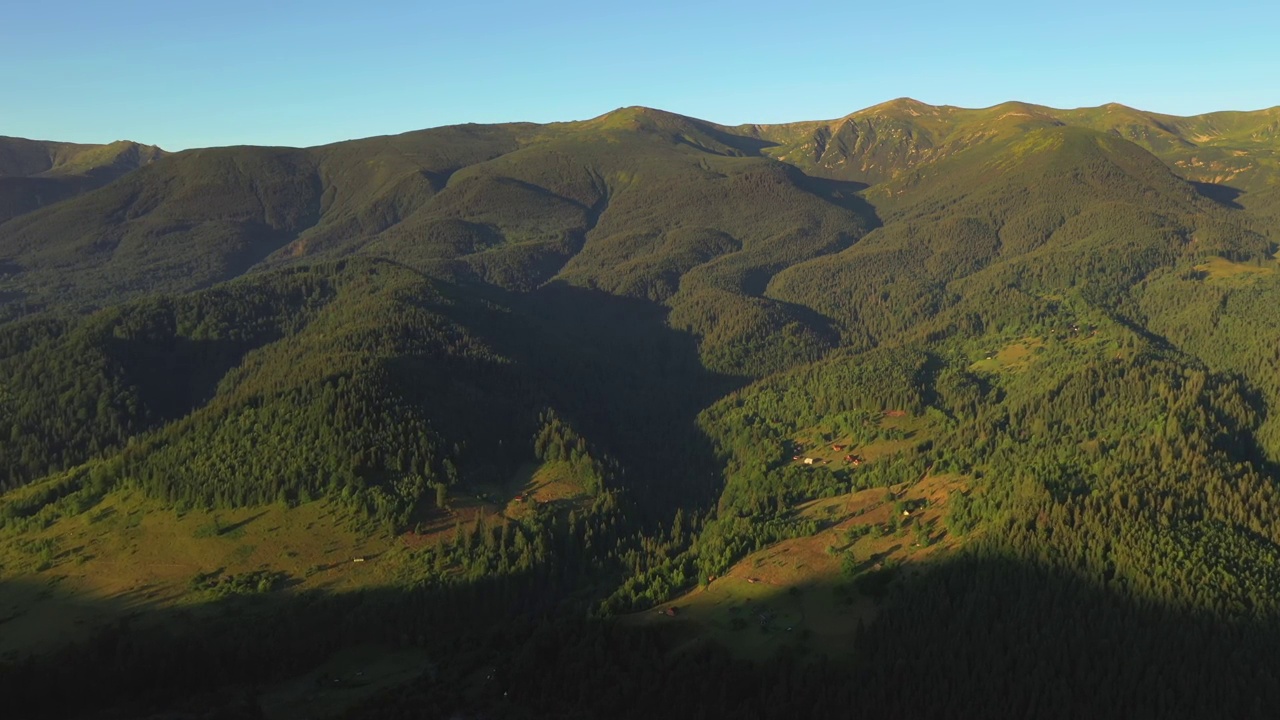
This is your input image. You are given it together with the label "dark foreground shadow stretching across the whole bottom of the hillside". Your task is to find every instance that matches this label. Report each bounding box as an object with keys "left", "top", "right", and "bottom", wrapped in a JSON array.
[{"left": 0, "top": 545, "right": 1280, "bottom": 720}]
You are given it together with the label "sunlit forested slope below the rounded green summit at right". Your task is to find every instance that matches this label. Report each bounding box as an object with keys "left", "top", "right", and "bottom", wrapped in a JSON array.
[{"left": 768, "top": 121, "right": 1271, "bottom": 346}]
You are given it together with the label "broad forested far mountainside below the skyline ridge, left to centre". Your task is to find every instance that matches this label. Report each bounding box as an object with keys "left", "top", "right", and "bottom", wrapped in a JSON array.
[{"left": 0, "top": 110, "right": 876, "bottom": 372}]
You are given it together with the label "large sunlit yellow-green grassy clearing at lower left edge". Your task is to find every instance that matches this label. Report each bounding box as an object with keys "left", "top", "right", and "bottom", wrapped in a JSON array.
[{"left": 0, "top": 492, "right": 407, "bottom": 656}]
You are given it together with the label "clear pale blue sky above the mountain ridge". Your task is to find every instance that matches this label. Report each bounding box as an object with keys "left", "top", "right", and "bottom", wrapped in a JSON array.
[{"left": 0, "top": 0, "right": 1280, "bottom": 150}]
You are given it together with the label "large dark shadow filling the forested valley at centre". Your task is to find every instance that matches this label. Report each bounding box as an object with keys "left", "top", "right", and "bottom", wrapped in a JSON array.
[{"left": 440, "top": 283, "right": 745, "bottom": 518}]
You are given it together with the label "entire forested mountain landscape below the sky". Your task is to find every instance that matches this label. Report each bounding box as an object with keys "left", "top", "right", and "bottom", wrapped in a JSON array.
[{"left": 0, "top": 99, "right": 1280, "bottom": 720}]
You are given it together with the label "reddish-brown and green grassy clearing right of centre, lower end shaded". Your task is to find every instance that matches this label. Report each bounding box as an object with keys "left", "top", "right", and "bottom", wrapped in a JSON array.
[{"left": 627, "top": 475, "right": 966, "bottom": 660}]
